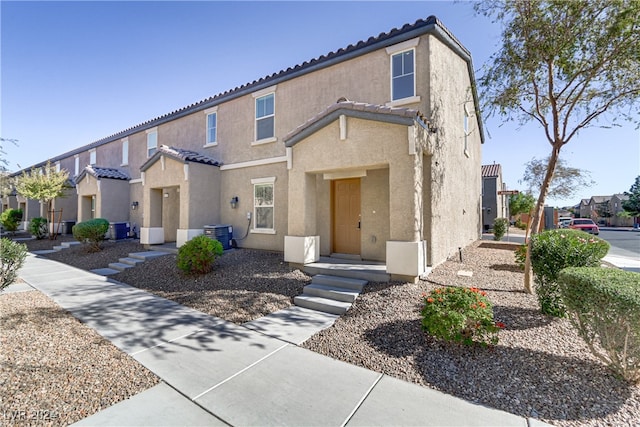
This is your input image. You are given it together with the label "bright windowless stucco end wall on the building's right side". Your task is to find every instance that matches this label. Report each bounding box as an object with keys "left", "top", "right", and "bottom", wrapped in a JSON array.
[{"left": 425, "top": 36, "right": 482, "bottom": 266}]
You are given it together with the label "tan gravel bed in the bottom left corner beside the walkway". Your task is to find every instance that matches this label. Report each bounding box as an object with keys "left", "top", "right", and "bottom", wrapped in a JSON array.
[{"left": 0, "top": 291, "right": 159, "bottom": 426}]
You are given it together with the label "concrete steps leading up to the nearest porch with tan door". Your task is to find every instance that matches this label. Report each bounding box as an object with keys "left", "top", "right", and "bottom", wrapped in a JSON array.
[{"left": 293, "top": 274, "right": 368, "bottom": 315}]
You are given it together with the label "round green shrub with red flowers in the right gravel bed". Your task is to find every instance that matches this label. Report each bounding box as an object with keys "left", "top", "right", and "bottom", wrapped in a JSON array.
[{"left": 422, "top": 288, "right": 504, "bottom": 346}]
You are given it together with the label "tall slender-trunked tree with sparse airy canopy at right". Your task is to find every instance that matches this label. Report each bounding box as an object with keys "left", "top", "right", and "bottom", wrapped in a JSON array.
[{"left": 475, "top": 0, "right": 640, "bottom": 293}]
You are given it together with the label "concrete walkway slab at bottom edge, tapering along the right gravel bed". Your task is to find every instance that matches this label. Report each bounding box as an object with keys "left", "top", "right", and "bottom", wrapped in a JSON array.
[{"left": 347, "top": 375, "right": 527, "bottom": 427}]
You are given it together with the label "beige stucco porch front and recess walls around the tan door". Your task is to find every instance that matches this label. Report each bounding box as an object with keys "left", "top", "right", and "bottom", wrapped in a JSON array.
[{"left": 288, "top": 117, "right": 422, "bottom": 260}]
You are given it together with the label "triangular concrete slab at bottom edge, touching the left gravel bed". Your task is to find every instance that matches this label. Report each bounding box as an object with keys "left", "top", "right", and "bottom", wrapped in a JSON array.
[{"left": 72, "top": 383, "right": 227, "bottom": 427}]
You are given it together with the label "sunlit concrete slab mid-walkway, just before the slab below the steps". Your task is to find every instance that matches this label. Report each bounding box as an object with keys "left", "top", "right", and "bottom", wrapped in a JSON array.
[{"left": 131, "top": 322, "right": 287, "bottom": 399}]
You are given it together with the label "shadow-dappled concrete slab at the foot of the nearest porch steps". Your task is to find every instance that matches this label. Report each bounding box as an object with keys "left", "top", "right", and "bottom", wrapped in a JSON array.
[{"left": 242, "top": 306, "right": 340, "bottom": 345}]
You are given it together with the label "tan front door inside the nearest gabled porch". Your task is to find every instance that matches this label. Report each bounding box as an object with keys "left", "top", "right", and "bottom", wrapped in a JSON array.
[{"left": 333, "top": 178, "right": 360, "bottom": 255}]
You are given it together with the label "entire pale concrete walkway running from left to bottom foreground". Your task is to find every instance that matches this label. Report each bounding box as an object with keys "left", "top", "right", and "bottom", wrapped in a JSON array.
[{"left": 13, "top": 255, "right": 545, "bottom": 426}]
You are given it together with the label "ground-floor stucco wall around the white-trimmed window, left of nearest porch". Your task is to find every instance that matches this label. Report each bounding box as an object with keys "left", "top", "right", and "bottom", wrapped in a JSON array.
[{"left": 220, "top": 162, "right": 289, "bottom": 251}]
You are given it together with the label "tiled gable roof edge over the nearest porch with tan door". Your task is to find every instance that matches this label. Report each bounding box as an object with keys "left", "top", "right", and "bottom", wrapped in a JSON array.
[{"left": 284, "top": 98, "right": 429, "bottom": 147}]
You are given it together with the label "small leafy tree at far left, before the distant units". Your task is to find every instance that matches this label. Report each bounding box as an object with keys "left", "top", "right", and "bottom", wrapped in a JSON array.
[{"left": 15, "top": 162, "right": 69, "bottom": 236}]
